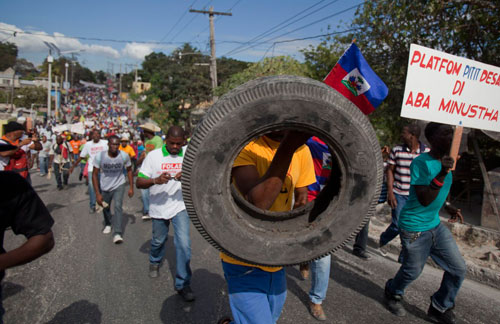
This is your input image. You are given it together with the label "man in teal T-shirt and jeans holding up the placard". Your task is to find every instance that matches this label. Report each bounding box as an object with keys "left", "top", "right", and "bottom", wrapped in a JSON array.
[{"left": 384, "top": 123, "right": 466, "bottom": 324}]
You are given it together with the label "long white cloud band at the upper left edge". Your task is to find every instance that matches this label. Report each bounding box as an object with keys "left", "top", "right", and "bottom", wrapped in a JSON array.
[{"left": 0, "top": 22, "right": 120, "bottom": 59}]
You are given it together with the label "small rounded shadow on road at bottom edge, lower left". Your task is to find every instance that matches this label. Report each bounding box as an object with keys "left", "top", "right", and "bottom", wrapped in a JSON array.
[{"left": 47, "top": 300, "right": 102, "bottom": 324}]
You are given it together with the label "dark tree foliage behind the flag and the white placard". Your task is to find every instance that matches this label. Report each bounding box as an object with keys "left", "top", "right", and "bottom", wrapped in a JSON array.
[{"left": 305, "top": 0, "right": 500, "bottom": 145}]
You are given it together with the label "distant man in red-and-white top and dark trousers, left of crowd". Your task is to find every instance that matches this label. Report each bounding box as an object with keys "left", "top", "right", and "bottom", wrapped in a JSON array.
[{"left": 49, "top": 135, "right": 71, "bottom": 190}]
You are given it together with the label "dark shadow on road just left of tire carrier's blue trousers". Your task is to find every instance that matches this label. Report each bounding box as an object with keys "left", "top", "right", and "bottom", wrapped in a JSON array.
[{"left": 160, "top": 269, "right": 231, "bottom": 324}]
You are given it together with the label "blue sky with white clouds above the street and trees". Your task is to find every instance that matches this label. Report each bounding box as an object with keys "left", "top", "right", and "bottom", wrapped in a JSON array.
[{"left": 0, "top": 0, "right": 364, "bottom": 73}]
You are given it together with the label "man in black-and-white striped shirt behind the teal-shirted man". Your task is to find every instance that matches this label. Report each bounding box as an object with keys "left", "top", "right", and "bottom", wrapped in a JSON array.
[{"left": 379, "top": 124, "right": 429, "bottom": 254}]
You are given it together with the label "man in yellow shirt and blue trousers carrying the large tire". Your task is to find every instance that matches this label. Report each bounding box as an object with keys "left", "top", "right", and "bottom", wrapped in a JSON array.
[{"left": 219, "top": 131, "right": 316, "bottom": 324}]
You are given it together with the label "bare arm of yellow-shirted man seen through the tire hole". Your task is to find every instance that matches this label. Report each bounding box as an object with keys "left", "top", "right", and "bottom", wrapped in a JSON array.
[{"left": 232, "top": 132, "right": 310, "bottom": 210}]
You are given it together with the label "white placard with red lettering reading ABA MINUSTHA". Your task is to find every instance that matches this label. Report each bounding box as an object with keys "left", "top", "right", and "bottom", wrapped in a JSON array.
[{"left": 401, "top": 44, "right": 500, "bottom": 132}]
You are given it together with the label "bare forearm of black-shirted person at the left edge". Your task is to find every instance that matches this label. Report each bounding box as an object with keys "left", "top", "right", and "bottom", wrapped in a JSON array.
[{"left": 0, "top": 231, "right": 54, "bottom": 270}]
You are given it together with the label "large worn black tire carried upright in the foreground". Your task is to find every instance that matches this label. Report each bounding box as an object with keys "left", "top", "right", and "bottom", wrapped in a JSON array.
[{"left": 182, "top": 76, "right": 383, "bottom": 266}]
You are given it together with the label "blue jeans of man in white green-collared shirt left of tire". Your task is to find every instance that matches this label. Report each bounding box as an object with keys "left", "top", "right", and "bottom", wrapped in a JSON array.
[{"left": 149, "top": 209, "right": 191, "bottom": 290}]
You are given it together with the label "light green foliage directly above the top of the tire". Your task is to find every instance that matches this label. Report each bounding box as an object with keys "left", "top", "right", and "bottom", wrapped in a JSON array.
[{"left": 215, "top": 56, "right": 309, "bottom": 96}]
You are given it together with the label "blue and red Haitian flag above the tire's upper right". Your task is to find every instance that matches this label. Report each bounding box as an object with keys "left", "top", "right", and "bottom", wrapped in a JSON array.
[{"left": 323, "top": 43, "right": 389, "bottom": 115}]
